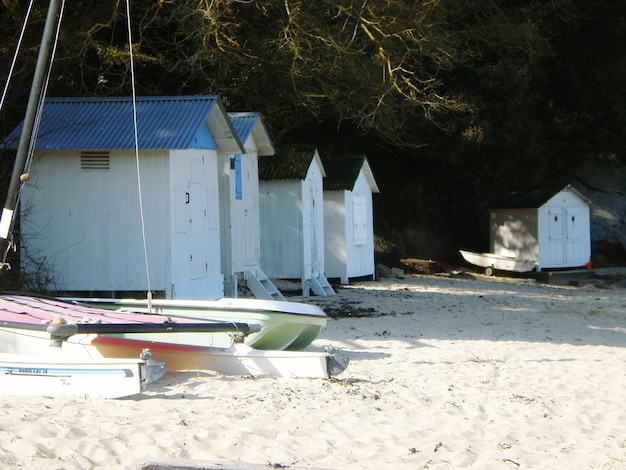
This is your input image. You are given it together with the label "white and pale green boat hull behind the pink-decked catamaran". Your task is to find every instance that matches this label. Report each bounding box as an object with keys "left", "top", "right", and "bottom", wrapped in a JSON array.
[{"left": 62, "top": 298, "right": 328, "bottom": 351}]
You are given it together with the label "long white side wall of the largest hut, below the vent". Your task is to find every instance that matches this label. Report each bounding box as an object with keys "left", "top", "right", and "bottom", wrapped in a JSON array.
[{"left": 22, "top": 151, "right": 168, "bottom": 290}]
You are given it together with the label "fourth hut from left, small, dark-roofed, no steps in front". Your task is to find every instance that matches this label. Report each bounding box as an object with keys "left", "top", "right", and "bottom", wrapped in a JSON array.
[{"left": 323, "top": 155, "right": 380, "bottom": 284}]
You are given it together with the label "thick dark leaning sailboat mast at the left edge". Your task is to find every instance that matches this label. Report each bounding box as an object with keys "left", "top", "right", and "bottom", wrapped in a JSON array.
[{"left": 0, "top": 0, "right": 62, "bottom": 269}]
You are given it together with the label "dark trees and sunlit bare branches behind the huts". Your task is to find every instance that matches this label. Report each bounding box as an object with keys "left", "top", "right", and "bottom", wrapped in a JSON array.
[{"left": 0, "top": 0, "right": 626, "bottom": 280}]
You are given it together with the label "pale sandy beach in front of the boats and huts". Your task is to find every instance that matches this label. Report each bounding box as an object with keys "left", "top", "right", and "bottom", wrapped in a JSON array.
[{"left": 0, "top": 274, "right": 626, "bottom": 469}]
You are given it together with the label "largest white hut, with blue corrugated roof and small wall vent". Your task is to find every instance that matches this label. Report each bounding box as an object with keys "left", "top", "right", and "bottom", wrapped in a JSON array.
[{"left": 15, "top": 96, "right": 244, "bottom": 299}]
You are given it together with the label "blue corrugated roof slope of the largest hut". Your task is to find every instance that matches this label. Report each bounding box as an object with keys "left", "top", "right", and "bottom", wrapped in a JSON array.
[{"left": 5, "top": 95, "right": 224, "bottom": 150}]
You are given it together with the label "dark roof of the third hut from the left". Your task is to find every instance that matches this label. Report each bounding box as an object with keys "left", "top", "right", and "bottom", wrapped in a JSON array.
[{"left": 259, "top": 145, "right": 317, "bottom": 181}]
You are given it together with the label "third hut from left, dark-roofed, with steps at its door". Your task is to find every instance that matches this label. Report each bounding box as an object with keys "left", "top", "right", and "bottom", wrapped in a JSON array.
[{"left": 259, "top": 146, "right": 335, "bottom": 295}]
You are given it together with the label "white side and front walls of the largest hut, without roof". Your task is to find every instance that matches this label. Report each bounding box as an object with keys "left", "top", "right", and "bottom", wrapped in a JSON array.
[{"left": 22, "top": 150, "right": 223, "bottom": 298}]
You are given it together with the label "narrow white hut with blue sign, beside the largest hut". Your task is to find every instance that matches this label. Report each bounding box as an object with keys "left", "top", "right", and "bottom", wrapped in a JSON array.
[{"left": 219, "top": 112, "right": 284, "bottom": 300}]
